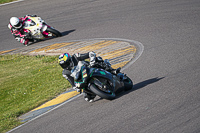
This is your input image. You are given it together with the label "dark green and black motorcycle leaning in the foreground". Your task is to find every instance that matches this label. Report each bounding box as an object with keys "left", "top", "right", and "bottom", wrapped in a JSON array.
[{"left": 71, "top": 61, "right": 133, "bottom": 100}]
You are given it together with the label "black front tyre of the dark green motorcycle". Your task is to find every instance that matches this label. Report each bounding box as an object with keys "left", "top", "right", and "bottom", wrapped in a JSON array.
[{"left": 90, "top": 84, "right": 116, "bottom": 100}]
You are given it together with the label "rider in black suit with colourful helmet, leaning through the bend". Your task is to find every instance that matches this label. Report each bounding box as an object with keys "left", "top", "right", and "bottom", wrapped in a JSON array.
[{"left": 58, "top": 52, "right": 121, "bottom": 102}]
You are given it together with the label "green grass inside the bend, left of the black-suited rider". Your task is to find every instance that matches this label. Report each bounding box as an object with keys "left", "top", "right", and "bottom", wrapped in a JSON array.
[{"left": 0, "top": 55, "right": 71, "bottom": 132}]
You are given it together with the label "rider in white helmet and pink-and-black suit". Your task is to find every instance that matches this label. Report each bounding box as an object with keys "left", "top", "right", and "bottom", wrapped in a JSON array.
[{"left": 8, "top": 15, "right": 37, "bottom": 46}]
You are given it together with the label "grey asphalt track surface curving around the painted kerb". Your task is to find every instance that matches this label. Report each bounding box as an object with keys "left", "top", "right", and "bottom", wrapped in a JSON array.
[{"left": 0, "top": 0, "right": 200, "bottom": 133}]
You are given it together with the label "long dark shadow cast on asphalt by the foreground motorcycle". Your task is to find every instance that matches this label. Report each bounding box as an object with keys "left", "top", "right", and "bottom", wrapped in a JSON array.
[{"left": 95, "top": 77, "right": 164, "bottom": 101}]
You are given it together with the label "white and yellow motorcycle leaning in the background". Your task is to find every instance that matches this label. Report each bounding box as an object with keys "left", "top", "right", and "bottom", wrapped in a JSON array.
[{"left": 23, "top": 17, "right": 62, "bottom": 40}]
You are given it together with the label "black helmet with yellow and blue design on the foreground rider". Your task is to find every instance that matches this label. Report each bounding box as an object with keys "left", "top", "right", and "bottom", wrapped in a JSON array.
[{"left": 58, "top": 53, "right": 72, "bottom": 69}]
